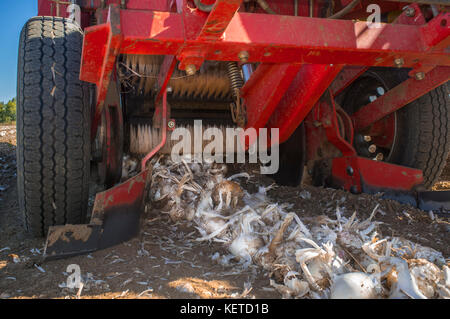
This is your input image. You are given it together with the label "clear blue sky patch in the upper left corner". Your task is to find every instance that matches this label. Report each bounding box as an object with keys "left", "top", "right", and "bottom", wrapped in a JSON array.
[{"left": 0, "top": 0, "right": 38, "bottom": 102}]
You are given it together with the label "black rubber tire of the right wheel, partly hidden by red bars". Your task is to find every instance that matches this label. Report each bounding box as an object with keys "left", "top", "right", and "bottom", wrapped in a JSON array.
[{"left": 342, "top": 68, "right": 450, "bottom": 188}]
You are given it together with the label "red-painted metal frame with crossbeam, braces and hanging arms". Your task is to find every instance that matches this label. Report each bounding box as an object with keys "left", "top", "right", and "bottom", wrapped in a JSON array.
[{"left": 39, "top": 0, "right": 450, "bottom": 195}]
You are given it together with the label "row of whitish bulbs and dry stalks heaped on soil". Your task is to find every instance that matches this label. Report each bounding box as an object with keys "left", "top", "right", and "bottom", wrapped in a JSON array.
[{"left": 142, "top": 157, "right": 450, "bottom": 299}]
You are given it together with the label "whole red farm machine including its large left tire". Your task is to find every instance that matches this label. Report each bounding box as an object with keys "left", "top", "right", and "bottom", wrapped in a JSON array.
[{"left": 17, "top": 0, "right": 450, "bottom": 258}]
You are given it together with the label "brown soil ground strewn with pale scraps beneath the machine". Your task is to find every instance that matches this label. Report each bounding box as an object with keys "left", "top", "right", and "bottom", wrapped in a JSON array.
[{"left": 0, "top": 125, "right": 450, "bottom": 299}]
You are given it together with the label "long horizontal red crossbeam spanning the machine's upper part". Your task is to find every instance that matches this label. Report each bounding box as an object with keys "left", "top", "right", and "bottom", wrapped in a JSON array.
[{"left": 80, "top": 10, "right": 450, "bottom": 83}]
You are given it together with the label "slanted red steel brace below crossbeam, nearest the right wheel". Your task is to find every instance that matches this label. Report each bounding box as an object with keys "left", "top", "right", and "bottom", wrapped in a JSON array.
[{"left": 267, "top": 64, "right": 343, "bottom": 143}]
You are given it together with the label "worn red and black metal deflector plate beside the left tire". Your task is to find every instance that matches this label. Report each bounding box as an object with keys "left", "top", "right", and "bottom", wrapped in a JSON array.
[{"left": 44, "top": 169, "right": 151, "bottom": 260}]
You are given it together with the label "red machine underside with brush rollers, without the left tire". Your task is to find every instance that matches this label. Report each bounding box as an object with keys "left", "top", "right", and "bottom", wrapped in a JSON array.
[{"left": 26, "top": 0, "right": 450, "bottom": 257}]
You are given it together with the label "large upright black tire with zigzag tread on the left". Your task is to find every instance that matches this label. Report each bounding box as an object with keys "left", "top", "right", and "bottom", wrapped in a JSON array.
[{"left": 17, "top": 17, "right": 90, "bottom": 236}]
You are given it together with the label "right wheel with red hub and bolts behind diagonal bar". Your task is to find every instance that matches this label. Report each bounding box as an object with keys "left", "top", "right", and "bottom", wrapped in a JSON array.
[{"left": 341, "top": 68, "right": 450, "bottom": 188}]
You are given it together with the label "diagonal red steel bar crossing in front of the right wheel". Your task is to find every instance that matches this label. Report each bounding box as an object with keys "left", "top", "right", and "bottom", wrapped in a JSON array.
[{"left": 352, "top": 67, "right": 450, "bottom": 131}]
